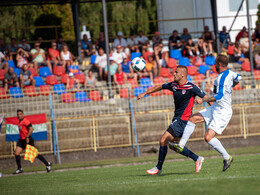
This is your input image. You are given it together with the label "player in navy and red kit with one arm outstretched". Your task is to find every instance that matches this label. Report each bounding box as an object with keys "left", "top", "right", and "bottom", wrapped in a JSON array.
[{"left": 138, "top": 66, "right": 211, "bottom": 175}]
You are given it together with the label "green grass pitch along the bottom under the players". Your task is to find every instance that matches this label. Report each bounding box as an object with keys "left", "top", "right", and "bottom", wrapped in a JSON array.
[{"left": 0, "top": 147, "right": 260, "bottom": 195}]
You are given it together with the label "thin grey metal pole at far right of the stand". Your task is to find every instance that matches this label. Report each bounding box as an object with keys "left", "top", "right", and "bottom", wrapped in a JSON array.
[{"left": 246, "top": 0, "right": 255, "bottom": 88}]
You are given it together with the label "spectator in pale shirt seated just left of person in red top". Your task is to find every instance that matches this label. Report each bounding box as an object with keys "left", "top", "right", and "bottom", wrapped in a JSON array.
[{"left": 30, "top": 42, "right": 52, "bottom": 73}]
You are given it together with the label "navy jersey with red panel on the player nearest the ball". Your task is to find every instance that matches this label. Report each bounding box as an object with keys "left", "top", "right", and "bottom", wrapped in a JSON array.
[{"left": 162, "top": 81, "right": 206, "bottom": 121}]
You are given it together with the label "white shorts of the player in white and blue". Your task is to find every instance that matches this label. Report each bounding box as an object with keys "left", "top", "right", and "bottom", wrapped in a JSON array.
[{"left": 200, "top": 105, "right": 232, "bottom": 134}]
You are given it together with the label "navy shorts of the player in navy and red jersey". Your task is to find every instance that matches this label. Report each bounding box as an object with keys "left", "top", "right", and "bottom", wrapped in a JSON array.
[{"left": 167, "top": 118, "right": 188, "bottom": 137}]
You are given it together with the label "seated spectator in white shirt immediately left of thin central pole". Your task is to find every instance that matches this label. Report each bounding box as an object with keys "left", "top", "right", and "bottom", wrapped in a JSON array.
[{"left": 94, "top": 47, "right": 107, "bottom": 80}]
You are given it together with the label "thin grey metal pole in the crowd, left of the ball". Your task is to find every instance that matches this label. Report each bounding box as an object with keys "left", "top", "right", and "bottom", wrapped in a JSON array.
[{"left": 102, "top": 0, "right": 111, "bottom": 88}]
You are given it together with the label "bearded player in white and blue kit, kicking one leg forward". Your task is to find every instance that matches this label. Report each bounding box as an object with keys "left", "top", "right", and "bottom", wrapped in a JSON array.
[{"left": 175, "top": 55, "right": 241, "bottom": 171}]
